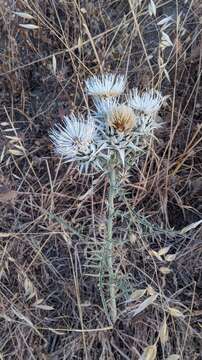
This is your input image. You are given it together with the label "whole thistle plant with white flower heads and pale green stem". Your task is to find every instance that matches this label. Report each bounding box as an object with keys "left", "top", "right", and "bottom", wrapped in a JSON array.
[{"left": 50, "top": 74, "right": 165, "bottom": 323}]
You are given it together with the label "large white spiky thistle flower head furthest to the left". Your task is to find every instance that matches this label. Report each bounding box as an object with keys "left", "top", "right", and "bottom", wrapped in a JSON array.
[{"left": 50, "top": 115, "right": 97, "bottom": 171}]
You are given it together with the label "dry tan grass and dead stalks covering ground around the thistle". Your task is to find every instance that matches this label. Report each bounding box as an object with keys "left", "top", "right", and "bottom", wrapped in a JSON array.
[{"left": 0, "top": 0, "right": 202, "bottom": 360}]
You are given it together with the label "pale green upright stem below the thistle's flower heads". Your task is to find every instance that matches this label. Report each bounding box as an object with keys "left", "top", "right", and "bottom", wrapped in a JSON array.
[{"left": 106, "top": 167, "right": 117, "bottom": 323}]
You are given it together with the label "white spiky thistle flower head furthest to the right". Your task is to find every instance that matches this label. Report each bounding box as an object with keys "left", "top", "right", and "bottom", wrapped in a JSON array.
[{"left": 128, "top": 89, "right": 164, "bottom": 115}]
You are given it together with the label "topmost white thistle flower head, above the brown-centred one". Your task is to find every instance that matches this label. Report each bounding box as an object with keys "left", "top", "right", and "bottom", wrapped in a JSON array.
[{"left": 86, "top": 74, "right": 126, "bottom": 97}]
